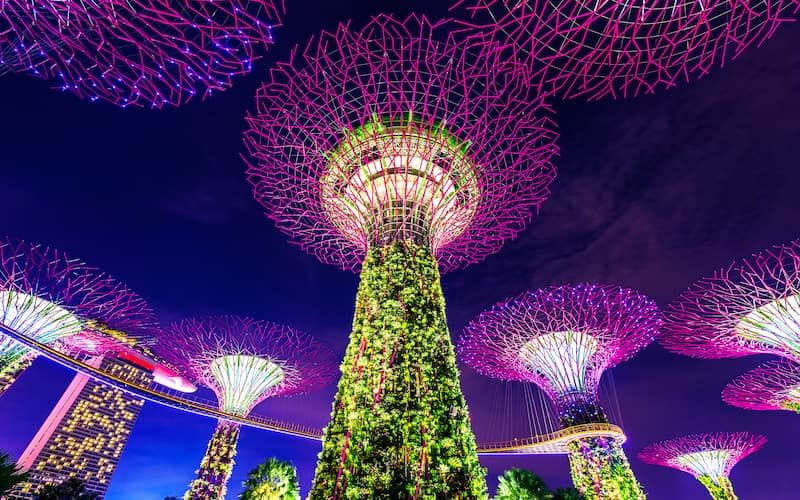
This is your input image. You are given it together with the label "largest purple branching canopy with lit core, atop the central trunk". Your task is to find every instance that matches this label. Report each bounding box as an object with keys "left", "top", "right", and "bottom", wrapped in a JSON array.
[{"left": 245, "top": 15, "right": 557, "bottom": 271}]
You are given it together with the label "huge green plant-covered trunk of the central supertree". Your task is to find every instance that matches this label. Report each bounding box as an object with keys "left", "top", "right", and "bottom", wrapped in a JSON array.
[{"left": 309, "top": 240, "right": 487, "bottom": 500}]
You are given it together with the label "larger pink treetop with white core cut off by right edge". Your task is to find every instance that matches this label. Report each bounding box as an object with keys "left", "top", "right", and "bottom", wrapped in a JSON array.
[{"left": 660, "top": 241, "right": 800, "bottom": 362}]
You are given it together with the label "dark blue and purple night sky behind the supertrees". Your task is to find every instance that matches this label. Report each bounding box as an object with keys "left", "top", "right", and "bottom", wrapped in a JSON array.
[{"left": 0, "top": 0, "right": 800, "bottom": 500}]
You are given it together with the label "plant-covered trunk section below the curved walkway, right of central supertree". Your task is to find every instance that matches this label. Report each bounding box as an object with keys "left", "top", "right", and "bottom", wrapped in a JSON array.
[{"left": 569, "top": 437, "right": 645, "bottom": 500}]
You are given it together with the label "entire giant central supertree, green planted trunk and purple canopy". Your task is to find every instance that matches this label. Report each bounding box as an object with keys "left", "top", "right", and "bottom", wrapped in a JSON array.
[{"left": 245, "top": 16, "right": 557, "bottom": 500}]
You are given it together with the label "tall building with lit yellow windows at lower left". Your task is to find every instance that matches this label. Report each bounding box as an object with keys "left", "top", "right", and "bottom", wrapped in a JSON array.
[{"left": 8, "top": 356, "right": 152, "bottom": 499}]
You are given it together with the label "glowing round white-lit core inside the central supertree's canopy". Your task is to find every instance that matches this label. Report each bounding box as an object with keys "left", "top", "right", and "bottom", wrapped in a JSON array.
[{"left": 320, "top": 120, "right": 480, "bottom": 248}]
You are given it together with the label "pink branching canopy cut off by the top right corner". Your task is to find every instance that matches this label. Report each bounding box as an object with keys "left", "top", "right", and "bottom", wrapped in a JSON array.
[{"left": 454, "top": 0, "right": 800, "bottom": 99}]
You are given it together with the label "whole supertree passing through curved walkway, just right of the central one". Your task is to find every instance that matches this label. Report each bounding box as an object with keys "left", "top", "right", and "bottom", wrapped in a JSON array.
[{"left": 459, "top": 284, "right": 662, "bottom": 499}]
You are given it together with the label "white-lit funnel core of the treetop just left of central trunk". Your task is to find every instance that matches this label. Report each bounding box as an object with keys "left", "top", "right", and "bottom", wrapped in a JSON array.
[{"left": 209, "top": 355, "right": 284, "bottom": 415}]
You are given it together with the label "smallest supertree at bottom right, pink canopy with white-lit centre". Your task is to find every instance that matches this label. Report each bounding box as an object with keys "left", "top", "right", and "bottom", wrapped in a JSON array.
[{"left": 639, "top": 432, "right": 767, "bottom": 500}]
